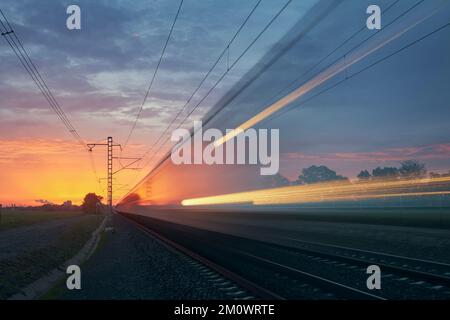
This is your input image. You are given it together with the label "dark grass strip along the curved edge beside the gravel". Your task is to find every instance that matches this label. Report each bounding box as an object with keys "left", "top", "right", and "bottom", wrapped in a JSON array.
[{"left": 0, "top": 215, "right": 103, "bottom": 299}]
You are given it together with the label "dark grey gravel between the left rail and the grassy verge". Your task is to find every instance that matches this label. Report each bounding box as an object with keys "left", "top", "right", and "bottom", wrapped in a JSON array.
[{"left": 59, "top": 215, "right": 230, "bottom": 299}]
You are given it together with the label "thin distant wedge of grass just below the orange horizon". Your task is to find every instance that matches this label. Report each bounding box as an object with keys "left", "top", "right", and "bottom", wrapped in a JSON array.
[{"left": 0, "top": 209, "right": 83, "bottom": 231}]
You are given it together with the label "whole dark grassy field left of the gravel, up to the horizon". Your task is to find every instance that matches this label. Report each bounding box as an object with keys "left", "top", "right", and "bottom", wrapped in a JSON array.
[{"left": 0, "top": 211, "right": 103, "bottom": 299}]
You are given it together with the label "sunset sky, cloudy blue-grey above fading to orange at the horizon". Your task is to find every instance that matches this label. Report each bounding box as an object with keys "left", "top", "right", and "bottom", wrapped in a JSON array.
[{"left": 0, "top": 0, "right": 450, "bottom": 204}]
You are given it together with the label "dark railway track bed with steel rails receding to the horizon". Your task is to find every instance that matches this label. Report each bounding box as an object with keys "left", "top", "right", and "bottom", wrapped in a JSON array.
[{"left": 118, "top": 214, "right": 450, "bottom": 300}]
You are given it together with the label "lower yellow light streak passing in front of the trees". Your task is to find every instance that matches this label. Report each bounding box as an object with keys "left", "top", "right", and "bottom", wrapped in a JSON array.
[{"left": 181, "top": 176, "right": 450, "bottom": 206}]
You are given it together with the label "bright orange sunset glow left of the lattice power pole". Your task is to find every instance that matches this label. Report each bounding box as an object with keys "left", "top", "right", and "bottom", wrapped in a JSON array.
[{"left": 0, "top": 139, "right": 102, "bottom": 205}]
